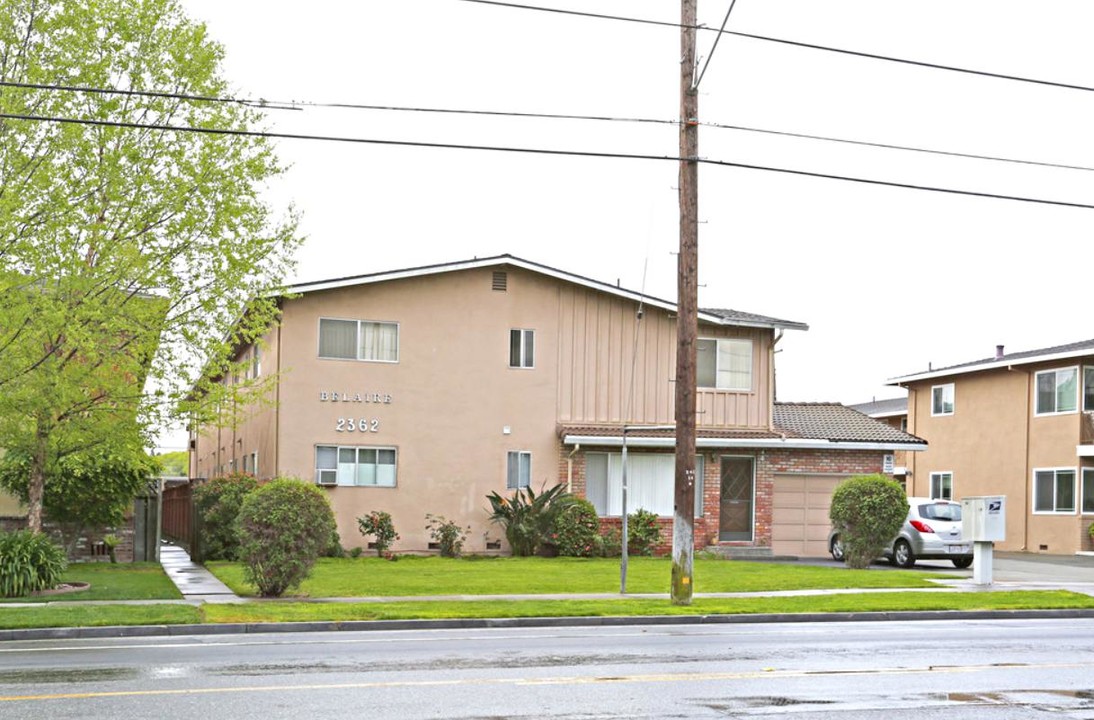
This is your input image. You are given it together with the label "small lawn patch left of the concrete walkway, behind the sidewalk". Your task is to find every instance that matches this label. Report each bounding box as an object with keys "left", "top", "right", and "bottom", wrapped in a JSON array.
[{"left": 0, "top": 562, "right": 183, "bottom": 603}]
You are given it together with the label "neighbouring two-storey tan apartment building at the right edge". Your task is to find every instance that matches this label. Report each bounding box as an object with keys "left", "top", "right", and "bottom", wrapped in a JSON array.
[{"left": 891, "top": 340, "right": 1094, "bottom": 554}]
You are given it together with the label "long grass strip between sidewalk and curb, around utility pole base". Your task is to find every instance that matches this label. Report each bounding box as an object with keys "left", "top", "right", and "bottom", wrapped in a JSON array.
[{"left": 202, "top": 590, "right": 1094, "bottom": 623}]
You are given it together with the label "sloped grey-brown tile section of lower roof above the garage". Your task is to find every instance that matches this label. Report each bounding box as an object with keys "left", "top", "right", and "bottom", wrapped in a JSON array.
[{"left": 775, "top": 403, "right": 927, "bottom": 445}]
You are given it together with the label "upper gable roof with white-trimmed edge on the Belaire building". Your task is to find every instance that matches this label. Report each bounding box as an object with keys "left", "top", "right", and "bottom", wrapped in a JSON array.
[{"left": 286, "top": 254, "right": 810, "bottom": 330}]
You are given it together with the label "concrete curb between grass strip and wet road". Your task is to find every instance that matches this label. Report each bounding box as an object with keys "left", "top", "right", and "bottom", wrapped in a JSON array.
[{"left": 6, "top": 608, "right": 1094, "bottom": 642}]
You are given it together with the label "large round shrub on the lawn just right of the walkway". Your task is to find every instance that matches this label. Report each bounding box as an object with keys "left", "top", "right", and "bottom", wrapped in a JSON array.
[{"left": 238, "top": 477, "right": 337, "bottom": 597}]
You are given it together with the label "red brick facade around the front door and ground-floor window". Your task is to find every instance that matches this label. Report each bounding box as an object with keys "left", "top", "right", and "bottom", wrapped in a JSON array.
[{"left": 559, "top": 446, "right": 885, "bottom": 555}]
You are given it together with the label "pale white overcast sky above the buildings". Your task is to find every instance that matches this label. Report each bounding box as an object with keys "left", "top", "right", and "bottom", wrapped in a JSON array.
[{"left": 156, "top": 0, "right": 1094, "bottom": 442}]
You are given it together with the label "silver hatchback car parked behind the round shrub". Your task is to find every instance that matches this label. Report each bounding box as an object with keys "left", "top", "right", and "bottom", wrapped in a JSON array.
[{"left": 828, "top": 498, "right": 973, "bottom": 568}]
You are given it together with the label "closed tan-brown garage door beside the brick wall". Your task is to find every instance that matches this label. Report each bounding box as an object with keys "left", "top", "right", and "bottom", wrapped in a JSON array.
[{"left": 771, "top": 474, "right": 845, "bottom": 557}]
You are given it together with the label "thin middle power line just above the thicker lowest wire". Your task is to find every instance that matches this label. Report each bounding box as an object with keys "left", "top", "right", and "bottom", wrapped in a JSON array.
[{"left": 0, "top": 76, "right": 1094, "bottom": 172}]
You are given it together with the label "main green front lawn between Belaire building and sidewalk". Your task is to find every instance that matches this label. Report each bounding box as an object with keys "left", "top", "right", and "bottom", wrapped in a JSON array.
[{"left": 208, "top": 556, "right": 947, "bottom": 597}]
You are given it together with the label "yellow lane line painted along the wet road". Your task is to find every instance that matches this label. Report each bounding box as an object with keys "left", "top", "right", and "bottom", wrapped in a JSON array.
[{"left": 0, "top": 663, "right": 1089, "bottom": 702}]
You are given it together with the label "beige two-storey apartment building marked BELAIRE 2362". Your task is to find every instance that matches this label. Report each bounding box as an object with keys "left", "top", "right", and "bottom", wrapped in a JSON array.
[{"left": 190, "top": 255, "right": 924, "bottom": 556}]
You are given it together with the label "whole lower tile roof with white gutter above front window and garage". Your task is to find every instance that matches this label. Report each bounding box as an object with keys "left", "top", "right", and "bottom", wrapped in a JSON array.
[{"left": 559, "top": 403, "right": 927, "bottom": 451}]
